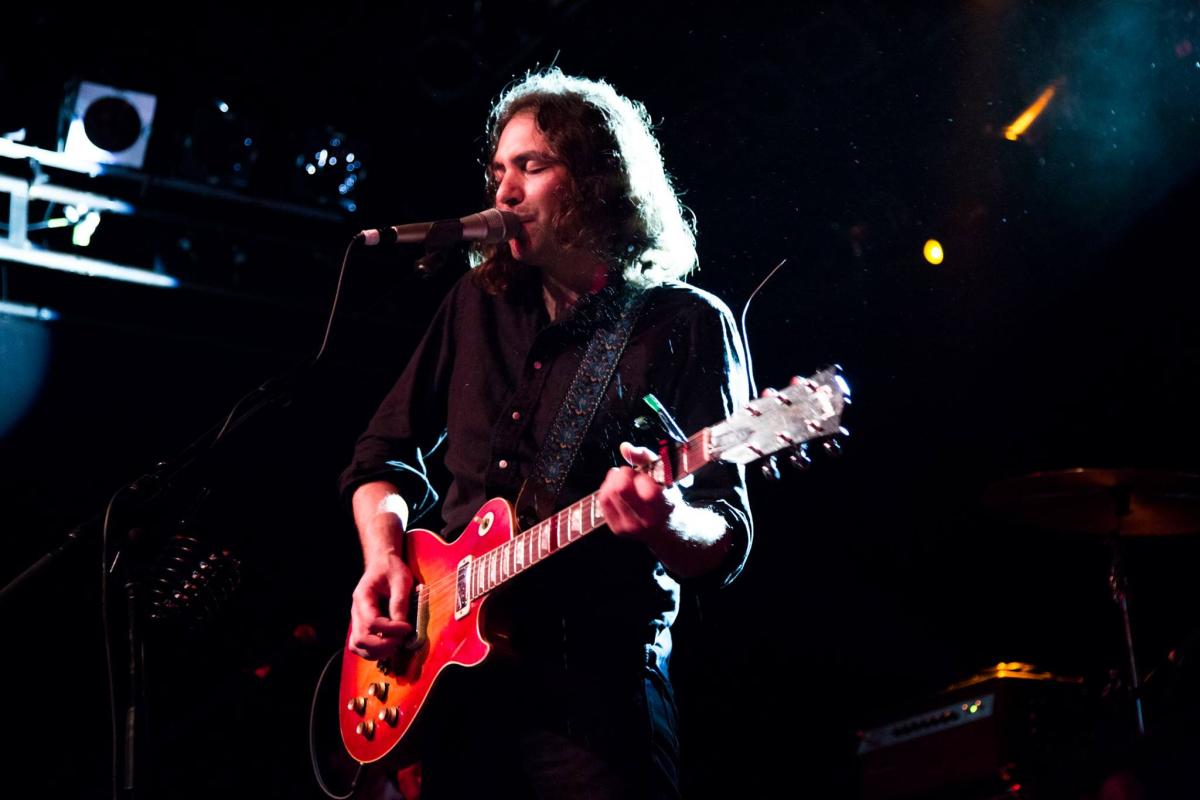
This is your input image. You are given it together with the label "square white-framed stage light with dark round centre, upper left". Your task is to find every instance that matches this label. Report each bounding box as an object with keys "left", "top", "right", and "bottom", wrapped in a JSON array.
[{"left": 59, "top": 80, "right": 157, "bottom": 169}]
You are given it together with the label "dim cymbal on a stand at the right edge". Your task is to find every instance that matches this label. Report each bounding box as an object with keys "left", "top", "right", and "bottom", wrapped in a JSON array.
[{"left": 984, "top": 469, "right": 1200, "bottom": 536}]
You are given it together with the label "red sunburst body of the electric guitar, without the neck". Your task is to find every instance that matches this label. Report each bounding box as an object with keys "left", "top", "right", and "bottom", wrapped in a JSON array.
[{"left": 338, "top": 499, "right": 515, "bottom": 764}]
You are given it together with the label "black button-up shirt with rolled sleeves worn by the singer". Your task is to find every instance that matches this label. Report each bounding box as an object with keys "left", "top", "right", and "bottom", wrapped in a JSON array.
[{"left": 341, "top": 270, "right": 751, "bottom": 753}]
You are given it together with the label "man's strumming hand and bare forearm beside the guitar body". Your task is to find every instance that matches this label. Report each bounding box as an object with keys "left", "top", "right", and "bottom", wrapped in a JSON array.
[{"left": 349, "top": 481, "right": 413, "bottom": 658}]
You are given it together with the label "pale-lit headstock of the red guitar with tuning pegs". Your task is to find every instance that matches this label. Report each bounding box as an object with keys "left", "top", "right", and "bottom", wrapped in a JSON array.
[{"left": 709, "top": 367, "right": 850, "bottom": 464}]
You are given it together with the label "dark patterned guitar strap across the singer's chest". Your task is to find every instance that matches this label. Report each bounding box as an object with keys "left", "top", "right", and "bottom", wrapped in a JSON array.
[{"left": 526, "top": 283, "right": 647, "bottom": 515}]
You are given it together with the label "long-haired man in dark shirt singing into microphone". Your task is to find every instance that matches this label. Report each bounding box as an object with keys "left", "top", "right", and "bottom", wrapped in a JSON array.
[{"left": 341, "top": 70, "right": 751, "bottom": 798}]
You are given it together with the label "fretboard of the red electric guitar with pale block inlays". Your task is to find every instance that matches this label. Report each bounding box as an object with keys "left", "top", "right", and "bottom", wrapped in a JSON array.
[{"left": 469, "top": 428, "right": 713, "bottom": 600}]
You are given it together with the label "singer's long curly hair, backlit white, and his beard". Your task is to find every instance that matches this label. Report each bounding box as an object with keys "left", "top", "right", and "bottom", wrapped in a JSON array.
[{"left": 470, "top": 67, "right": 696, "bottom": 294}]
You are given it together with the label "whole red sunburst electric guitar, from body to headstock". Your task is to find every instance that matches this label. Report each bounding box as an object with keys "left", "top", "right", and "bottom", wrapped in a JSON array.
[{"left": 338, "top": 368, "right": 850, "bottom": 764}]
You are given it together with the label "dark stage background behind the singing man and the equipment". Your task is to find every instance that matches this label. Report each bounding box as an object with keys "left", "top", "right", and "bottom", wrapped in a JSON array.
[{"left": 0, "top": 0, "right": 1200, "bottom": 796}]
